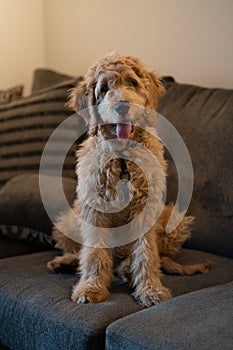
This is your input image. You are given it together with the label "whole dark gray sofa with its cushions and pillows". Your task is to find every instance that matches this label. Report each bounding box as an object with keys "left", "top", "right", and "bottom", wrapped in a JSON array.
[{"left": 0, "top": 70, "right": 233, "bottom": 350}]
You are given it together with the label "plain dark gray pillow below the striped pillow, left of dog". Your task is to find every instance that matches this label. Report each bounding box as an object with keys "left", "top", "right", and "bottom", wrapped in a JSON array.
[{"left": 0, "top": 174, "right": 76, "bottom": 246}]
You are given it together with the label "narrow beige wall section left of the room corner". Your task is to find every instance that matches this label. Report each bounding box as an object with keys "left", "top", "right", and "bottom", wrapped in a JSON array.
[{"left": 0, "top": 0, "right": 45, "bottom": 93}]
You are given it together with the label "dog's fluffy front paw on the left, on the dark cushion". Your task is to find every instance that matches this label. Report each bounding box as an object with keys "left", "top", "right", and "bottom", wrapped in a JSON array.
[{"left": 71, "top": 283, "right": 109, "bottom": 304}]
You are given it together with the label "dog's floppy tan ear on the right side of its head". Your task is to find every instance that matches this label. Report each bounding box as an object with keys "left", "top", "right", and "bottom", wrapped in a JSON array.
[{"left": 147, "top": 72, "right": 165, "bottom": 109}]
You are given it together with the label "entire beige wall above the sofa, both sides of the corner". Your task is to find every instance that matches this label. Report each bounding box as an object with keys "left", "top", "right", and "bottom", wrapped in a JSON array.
[{"left": 0, "top": 0, "right": 233, "bottom": 92}]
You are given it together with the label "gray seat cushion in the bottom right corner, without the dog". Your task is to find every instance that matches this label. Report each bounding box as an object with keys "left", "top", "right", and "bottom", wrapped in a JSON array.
[{"left": 106, "top": 282, "right": 233, "bottom": 350}]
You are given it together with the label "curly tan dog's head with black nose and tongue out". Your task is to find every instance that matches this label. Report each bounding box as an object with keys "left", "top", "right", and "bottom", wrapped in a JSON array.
[{"left": 68, "top": 52, "right": 164, "bottom": 139}]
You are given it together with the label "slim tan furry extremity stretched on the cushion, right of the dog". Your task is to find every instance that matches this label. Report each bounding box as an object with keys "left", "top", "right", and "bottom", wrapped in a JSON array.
[{"left": 161, "top": 256, "right": 213, "bottom": 275}]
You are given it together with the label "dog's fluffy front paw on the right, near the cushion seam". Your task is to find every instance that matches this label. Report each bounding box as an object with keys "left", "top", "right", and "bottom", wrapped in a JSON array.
[{"left": 132, "top": 286, "right": 172, "bottom": 307}]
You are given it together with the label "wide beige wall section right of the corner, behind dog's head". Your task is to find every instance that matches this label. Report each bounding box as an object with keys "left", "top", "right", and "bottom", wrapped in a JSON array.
[{"left": 45, "top": 0, "right": 233, "bottom": 87}]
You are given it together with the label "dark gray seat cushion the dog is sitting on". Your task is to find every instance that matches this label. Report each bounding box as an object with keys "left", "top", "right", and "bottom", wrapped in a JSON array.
[{"left": 0, "top": 249, "right": 233, "bottom": 350}]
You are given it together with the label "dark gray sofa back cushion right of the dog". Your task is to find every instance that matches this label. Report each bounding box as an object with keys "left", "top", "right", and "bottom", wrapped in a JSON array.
[{"left": 158, "top": 83, "right": 233, "bottom": 257}]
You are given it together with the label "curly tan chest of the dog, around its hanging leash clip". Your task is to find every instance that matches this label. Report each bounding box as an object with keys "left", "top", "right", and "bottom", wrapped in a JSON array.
[{"left": 77, "top": 139, "right": 164, "bottom": 224}]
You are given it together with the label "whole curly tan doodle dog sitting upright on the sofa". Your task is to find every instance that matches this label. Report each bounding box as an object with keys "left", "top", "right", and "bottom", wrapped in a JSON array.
[{"left": 48, "top": 53, "right": 210, "bottom": 307}]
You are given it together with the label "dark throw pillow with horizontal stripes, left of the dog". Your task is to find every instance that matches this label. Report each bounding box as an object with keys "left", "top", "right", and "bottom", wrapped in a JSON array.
[{"left": 0, "top": 78, "right": 81, "bottom": 187}]
